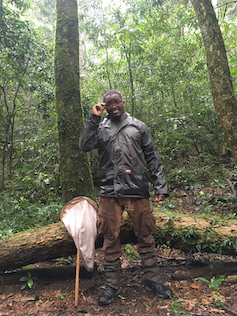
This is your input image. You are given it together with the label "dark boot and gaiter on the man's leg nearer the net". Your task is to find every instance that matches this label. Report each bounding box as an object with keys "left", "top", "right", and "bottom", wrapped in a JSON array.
[{"left": 98, "top": 259, "right": 120, "bottom": 306}]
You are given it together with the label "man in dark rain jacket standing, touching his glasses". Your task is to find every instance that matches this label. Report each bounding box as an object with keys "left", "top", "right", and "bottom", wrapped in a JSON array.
[{"left": 79, "top": 90, "right": 173, "bottom": 305}]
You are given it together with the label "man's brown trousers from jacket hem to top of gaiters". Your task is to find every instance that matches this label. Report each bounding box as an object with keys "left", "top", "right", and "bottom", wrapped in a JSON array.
[{"left": 98, "top": 196, "right": 155, "bottom": 261}]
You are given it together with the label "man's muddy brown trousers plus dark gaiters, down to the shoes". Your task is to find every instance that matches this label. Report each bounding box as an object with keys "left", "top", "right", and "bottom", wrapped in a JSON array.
[{"left": 98, "top": 197, "right": 161, "bottom": 289}]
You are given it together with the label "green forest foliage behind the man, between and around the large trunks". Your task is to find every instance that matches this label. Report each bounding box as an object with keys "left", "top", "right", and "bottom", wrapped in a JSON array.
[{"left": 0, "top": 0, "right": 237, "bottom": 237}]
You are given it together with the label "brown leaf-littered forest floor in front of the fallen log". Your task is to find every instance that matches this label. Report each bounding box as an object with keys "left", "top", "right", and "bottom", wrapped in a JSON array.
[{"left": 0, "top": 246, "right": 237, "bottom": 316}]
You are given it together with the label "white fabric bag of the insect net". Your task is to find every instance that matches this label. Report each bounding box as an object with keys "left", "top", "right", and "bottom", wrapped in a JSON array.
[{"left": 62, "top": 200, "right": 97, "bottom": 271}]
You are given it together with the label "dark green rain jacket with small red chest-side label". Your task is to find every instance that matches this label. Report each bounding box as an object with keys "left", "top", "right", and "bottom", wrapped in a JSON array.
[{"left": 79, "top": 112, "right": 168, "bottom": 198}]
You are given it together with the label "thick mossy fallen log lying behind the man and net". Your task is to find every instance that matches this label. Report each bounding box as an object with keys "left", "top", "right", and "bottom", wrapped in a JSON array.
[{"left": 0, "top": 212, "right": 237, "bottom": 271}]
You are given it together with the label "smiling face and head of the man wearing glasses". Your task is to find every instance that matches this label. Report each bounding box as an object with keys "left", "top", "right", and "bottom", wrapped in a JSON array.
[{"left": 104, "top": 93, "right": 125, "bottom": 122}]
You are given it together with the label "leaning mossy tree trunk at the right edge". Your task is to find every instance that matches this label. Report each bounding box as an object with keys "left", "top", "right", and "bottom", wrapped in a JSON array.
[{"left": 191, "top": 0, "right": 237, "bottom": 167}]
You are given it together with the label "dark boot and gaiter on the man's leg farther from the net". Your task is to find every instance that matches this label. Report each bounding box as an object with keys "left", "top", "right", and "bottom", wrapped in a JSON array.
[{"left": 141, "top": 252, "right": 173, "bottom": 298}]
